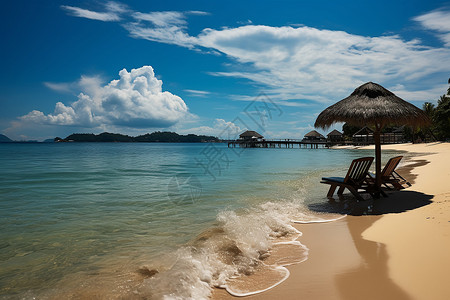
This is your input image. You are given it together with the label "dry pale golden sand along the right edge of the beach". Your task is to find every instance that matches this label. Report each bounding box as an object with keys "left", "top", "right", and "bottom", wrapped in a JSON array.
[{"left": 363, "top": 143, "right": 450, "bottom": 299}]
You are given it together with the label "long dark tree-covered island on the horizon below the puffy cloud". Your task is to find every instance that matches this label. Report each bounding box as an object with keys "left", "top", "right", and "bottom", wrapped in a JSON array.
[{"left": 54, "top": 131, "right": 220, "bottom": 143}]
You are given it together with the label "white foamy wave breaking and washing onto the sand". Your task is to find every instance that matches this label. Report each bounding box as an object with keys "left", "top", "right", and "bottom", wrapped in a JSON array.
[{"left": 140, "top": 202, "right": 344, "bottom": 299}]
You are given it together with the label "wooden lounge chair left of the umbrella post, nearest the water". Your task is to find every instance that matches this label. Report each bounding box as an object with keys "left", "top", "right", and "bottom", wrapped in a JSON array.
[{"left": 320, "top": 157, "right": 373, "bottom": 200}]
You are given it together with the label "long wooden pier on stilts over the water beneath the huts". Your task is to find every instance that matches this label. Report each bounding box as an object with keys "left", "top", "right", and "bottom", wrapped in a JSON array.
[{"left": 228, "top": 139, "right": 332, "bottom": 149}]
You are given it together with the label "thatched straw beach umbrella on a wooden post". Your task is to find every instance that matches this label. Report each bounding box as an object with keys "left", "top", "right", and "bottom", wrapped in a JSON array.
[{"left": 314, "top": 82, "right": 430, "bottom": 189}]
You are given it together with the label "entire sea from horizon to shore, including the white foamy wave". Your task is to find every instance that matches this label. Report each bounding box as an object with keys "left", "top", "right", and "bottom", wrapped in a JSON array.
[{"left": 0, "top": 143, "right": 404, "bottom": 299}]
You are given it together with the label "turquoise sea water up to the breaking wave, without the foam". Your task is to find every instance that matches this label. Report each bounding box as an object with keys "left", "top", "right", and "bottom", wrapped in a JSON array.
[{"left": 0, "top": 143, "right": 402, "bottom": 298}]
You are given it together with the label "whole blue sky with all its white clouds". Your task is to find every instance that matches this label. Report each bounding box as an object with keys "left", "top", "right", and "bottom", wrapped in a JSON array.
[{"left": 0, "top": 0, "right": 450, "bottom": 140}]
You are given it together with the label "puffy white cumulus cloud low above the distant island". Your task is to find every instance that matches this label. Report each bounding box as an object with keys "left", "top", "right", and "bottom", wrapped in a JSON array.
[{"left": 20, "top": 66, "right": 188, "bottom": 128}]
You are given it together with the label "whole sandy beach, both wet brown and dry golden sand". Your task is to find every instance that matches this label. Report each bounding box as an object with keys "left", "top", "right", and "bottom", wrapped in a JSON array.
[{"left": 212, "top": 143, "right": 450, "bottom": 299}]
